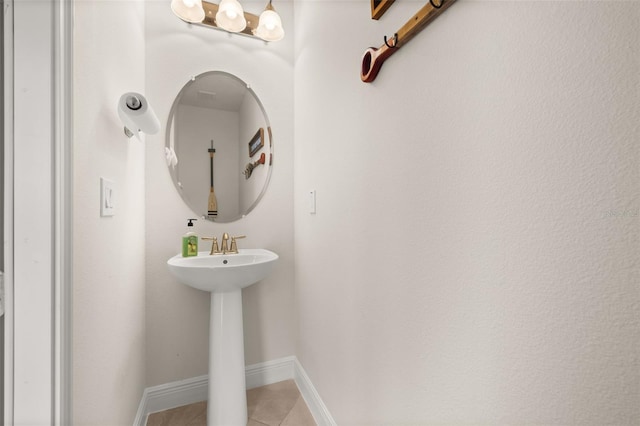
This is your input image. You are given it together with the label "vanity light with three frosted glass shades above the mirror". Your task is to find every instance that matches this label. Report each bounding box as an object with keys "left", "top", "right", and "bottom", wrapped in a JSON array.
[{"left": 171, "top": 0, "right": 284, "bottom": 41}]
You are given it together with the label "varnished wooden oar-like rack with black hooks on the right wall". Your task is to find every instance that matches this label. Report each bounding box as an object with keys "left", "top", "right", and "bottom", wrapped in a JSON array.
[{"left": 360, "top": 0, "right": 455, "bottom": 83}]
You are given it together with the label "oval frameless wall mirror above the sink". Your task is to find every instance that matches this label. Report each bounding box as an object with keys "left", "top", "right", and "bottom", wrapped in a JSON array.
[{"left": 165, "top": 71, "right": 273, "bottom": 223}]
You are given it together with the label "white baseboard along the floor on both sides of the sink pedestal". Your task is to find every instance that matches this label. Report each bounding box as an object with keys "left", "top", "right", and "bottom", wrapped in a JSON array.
[{"left": 133, "top": 356, "right": 336, "bottom": 426}]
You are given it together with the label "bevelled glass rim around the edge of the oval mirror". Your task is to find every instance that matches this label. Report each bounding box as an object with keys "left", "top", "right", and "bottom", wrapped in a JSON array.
[{"left": 165, "top": 70, "right": 274, "bottom": 223}]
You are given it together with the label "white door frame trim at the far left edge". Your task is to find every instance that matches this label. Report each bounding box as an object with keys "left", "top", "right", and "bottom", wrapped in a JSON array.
[{"left": 3, "top": 0, "right": 73, "bottom": 425}]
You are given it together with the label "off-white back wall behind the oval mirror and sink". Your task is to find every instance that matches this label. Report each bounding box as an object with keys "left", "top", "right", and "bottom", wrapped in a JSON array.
[{"left": 145, "top": 0, "right": 295, "bottom": 386}]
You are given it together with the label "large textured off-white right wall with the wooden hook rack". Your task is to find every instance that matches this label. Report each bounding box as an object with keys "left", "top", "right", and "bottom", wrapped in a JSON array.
[{"left": 294, "top": 1, "right": 640, "bottom": 425}]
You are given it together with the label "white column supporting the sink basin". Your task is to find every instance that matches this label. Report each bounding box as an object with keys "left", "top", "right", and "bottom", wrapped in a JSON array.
[{"left": 207, "top": 289, "right": 247, "bottom": 426}]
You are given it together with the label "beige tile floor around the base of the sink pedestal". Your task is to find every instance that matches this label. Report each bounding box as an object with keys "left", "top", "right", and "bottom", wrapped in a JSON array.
[{"left": 147, "top": 380, "right": 316, "bottom": 426}]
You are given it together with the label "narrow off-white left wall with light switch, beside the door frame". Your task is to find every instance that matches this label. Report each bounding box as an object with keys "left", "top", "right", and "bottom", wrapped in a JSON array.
[{"left": 73, "top": 0, "right": 146, "bottom": 425}]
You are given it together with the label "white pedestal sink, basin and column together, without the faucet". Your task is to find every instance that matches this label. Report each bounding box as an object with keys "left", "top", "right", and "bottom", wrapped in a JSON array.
[{"left": 167, "top": 249, "right": 278, "bottom": 426}]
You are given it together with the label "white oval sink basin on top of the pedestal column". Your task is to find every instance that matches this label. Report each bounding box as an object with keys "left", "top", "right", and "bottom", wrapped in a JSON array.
[{"left": 167, "top": 249, "right": 278, "bottom": 292}]
